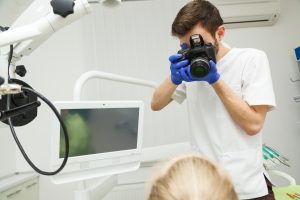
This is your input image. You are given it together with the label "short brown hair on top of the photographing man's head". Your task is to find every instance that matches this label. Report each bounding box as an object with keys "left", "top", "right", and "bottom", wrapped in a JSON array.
[{"left": 172, "top": 0, "right": 223, "bottom": 37}]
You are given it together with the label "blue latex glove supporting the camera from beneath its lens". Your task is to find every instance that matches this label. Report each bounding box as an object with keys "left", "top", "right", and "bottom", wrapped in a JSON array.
[{"left": 180, "top": 60, "right": 220, "bottom": 84}]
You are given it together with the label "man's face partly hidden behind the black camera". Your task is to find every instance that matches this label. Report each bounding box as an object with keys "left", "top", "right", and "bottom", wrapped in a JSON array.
[{"left": 179, "top": 24, "right": 219, "bottom": 54}]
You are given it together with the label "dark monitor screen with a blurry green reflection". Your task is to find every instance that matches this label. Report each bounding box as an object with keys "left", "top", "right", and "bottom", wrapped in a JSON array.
[{"left": 59, "top": 108, "right": 139, "bottom": 158}]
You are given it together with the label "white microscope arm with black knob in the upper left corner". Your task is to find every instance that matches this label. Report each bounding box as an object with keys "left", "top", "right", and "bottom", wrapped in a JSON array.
[{"left": 0, "top": 0, "right": 91, "bottom": 61}]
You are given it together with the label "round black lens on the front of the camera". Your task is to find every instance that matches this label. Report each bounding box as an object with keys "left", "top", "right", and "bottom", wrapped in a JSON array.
[{"left": 190, "top": 58, "right": 210, "bottom": 78}]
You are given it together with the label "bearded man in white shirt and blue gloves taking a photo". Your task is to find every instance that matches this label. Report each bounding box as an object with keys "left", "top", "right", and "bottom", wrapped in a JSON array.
[{"left": 151, "top": 0, "right": 275, "bottom": 200}]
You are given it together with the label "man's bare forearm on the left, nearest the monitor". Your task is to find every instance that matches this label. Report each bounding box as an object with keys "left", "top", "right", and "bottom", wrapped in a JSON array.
[{"left": 151, "top": 77, "right": 177, "bottom": 111}]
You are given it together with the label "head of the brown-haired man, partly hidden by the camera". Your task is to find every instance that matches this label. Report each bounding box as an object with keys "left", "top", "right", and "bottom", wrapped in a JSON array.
[{"left": 172, "top": 0, "right": 225, "bottom": 52}]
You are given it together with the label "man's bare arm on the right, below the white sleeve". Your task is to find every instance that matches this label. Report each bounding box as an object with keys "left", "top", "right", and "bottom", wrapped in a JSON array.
[{"left": 212, "top": 80, "right": 268, "bottom": 136}]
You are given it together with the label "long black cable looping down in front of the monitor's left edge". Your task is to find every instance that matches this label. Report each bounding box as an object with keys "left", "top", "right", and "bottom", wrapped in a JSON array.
[{"left": 7, "top": 86, "right": 69, "bottom": 176}]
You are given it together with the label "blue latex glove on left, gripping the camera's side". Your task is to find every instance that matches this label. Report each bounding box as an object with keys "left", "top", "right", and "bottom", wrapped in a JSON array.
[{"left": 169, "top": 54, "right": 189, "bottom": 85}]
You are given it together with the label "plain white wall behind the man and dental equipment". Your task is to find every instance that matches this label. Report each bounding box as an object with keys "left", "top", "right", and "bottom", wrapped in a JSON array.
[{"left": 0, "top": 0, "right": 300, "bottom": 200}]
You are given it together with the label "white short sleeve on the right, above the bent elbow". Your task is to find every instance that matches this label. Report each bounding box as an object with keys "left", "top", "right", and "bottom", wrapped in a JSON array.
[{"left": 242, "top": 50, "right": 276, "bottom": 109}]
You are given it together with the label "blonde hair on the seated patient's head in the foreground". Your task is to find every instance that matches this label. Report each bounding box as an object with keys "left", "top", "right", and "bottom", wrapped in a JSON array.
[{"left": 148, "top": 154, "right": 238, "bottom": 200}]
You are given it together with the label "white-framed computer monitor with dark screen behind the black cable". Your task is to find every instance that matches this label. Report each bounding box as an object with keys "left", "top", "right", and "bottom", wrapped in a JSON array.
[{"left": 51, "top": 101, "right": 144, "bottom": 184}]
